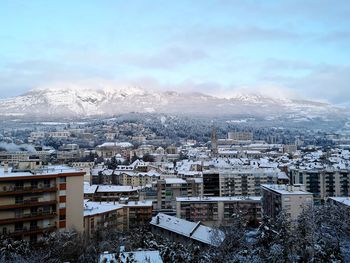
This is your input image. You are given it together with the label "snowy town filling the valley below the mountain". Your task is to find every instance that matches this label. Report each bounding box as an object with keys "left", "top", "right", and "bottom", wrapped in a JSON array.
[{"left": 0, "top": 115, "right": 350, "bottom": 262}]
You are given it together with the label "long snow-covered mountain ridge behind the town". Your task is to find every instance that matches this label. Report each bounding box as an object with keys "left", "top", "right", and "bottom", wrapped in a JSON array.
[{"left": 0, "top": 85, "right": 342, "bottom": 119}]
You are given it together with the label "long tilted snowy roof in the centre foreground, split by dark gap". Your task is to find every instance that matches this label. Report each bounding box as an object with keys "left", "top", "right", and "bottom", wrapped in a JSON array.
[{"left": 151, "top": 213, "right": 225, "bottom": 246}]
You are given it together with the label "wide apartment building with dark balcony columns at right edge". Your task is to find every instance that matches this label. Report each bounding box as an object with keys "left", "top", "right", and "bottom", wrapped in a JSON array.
[{"left": 289, "top": 168, "right": 350, "bottom": 202}]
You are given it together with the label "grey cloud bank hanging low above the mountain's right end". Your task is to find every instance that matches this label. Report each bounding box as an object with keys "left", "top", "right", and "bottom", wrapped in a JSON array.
[{"left": 258, "top": 59, "right": 350, "bottom": 104}]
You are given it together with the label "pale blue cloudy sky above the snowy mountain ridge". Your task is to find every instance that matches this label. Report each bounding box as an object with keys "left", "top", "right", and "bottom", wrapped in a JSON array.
[{"left": 0, "top": 0, "right": 350, "bottom": 105}]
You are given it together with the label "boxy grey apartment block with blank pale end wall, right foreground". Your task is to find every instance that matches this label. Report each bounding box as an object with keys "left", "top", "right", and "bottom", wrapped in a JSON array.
[{"left": 261, "top": 184, "right": 313, "bottom": 219}]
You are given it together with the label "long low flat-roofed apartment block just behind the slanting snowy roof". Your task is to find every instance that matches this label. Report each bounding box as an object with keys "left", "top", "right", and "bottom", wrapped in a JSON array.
[{"left": 176, "top": 196, "right": 262, "bottom": 226}]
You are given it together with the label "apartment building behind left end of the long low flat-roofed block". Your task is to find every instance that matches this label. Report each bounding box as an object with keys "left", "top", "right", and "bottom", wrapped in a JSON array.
[{"left": 155, "top": 178, "right": 203, "bottom": 214}]
